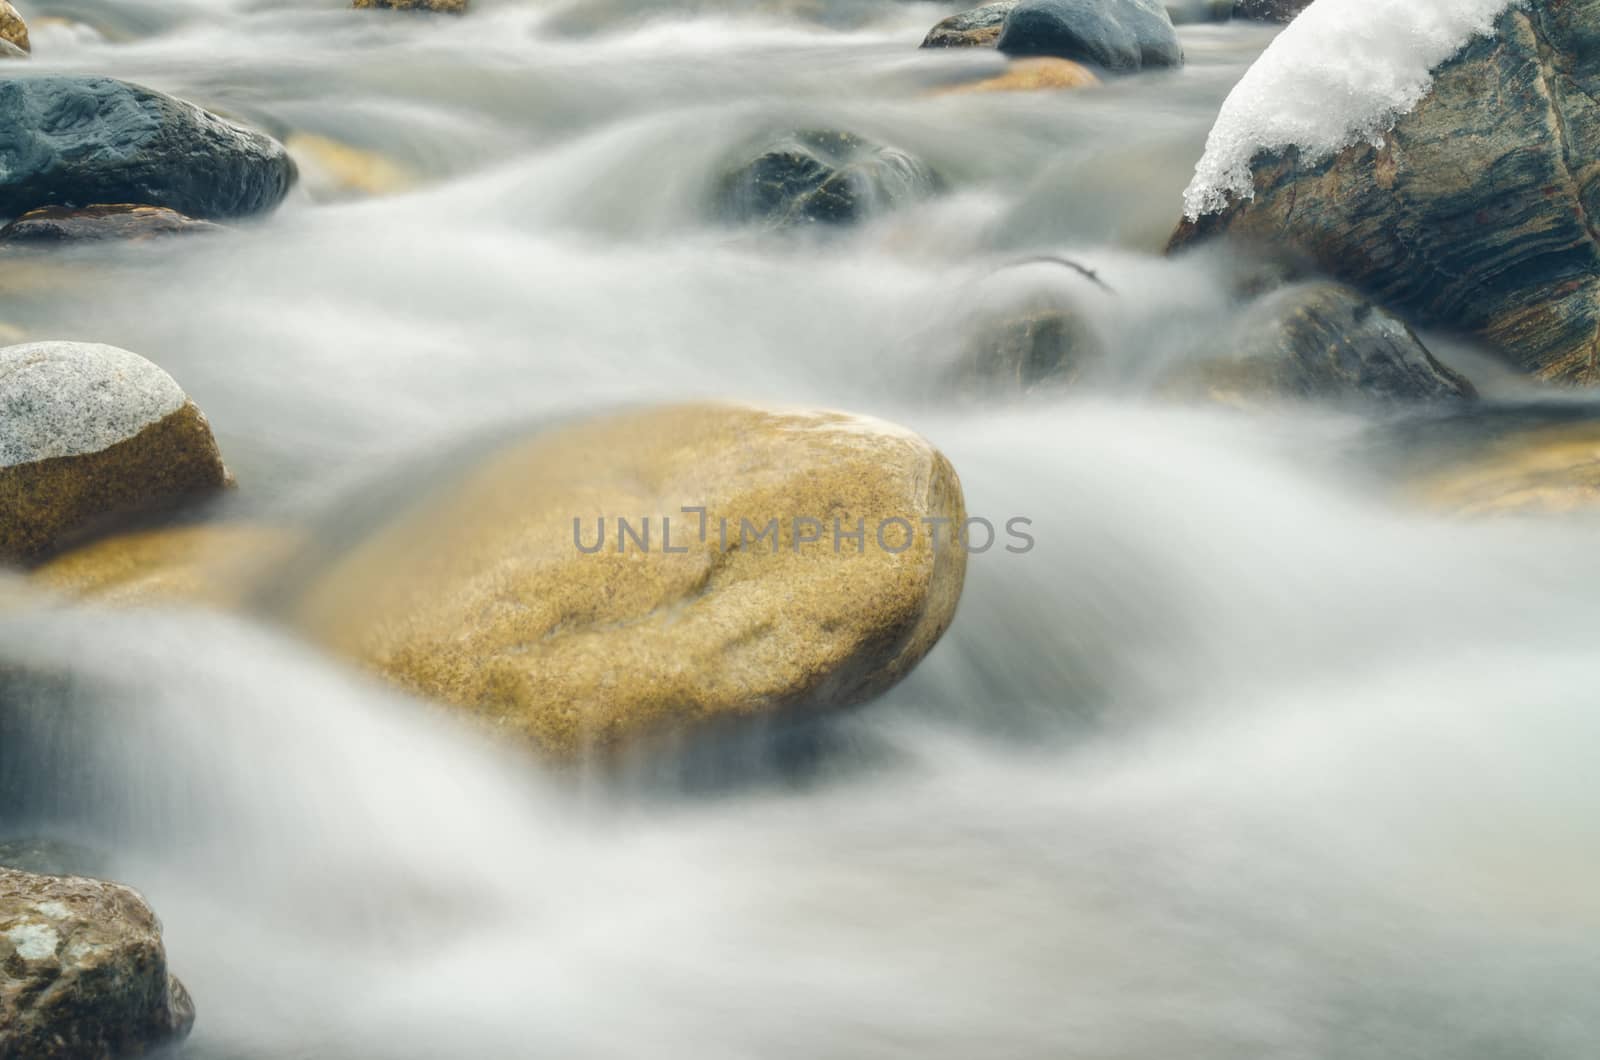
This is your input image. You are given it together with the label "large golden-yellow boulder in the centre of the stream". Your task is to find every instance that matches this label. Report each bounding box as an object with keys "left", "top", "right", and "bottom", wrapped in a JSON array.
[{"left": 266, "top": 405, "right": 981, "bottom": 759}]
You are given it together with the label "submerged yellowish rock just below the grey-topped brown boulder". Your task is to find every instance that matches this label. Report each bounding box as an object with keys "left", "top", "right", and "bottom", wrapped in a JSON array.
[{"left": 29, "top": 524, "right": 299, "bottom": 608}]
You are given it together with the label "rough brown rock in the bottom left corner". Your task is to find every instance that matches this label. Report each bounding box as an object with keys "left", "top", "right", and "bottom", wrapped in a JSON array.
[{"left": 0, "top": 868, "right": 195, "bottom": 1060}]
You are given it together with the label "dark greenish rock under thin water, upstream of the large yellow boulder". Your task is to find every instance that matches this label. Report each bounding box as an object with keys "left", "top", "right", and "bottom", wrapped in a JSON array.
[{"left": 717, "top": 130, "right": 939, "bottom": 227}]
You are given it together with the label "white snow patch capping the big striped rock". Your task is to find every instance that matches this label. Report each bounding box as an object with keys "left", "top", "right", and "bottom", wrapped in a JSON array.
[{"left": 1184, "top": 0, "right": 1525, "bottom": 221}]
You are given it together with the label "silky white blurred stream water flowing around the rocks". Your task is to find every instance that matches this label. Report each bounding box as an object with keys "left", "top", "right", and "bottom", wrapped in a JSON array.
[{"left": 0, "top": 0, "right": 1600, "bottom": 1060}]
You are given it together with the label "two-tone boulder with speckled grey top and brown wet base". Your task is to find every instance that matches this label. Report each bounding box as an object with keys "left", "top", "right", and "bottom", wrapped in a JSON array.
[{"left": 0, "top": 343, "right": 229, "bottom": 562}]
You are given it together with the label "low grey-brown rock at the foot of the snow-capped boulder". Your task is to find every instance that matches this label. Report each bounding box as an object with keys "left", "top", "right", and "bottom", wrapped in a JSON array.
[{"left": 1168, "top": 283, "right": 1477, "bottom": 404}]
